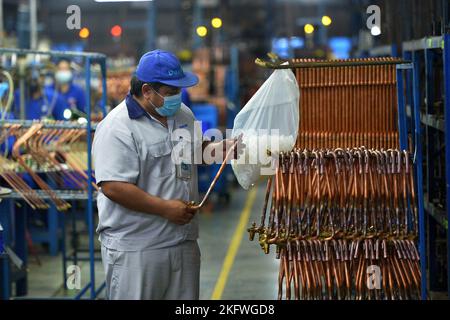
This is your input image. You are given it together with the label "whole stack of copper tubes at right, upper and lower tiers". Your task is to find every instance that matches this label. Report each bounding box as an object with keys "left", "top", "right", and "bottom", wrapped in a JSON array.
[{"left": 248, "top": 58, "right": 421, "bottom": 300}]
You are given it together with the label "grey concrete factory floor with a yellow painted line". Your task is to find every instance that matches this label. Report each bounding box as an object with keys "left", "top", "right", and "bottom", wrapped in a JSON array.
[{"left": 15, "top": 184, "right": 278, "bottom": 299}]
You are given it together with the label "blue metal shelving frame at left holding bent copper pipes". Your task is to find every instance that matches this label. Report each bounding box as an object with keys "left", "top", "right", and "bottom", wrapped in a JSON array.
[{"left": 0, "top": 48, "right": 106, "bottom": 299}]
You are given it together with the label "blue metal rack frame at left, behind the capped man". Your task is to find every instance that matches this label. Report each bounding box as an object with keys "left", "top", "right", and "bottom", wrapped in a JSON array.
[{"left": 0, "top": 48, "right": 107, "bottom": 299}]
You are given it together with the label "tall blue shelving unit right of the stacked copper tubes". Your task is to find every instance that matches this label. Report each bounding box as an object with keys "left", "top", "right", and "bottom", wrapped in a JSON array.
[{"left": 403, "top": 34, "right": 450, "bottom": 297}]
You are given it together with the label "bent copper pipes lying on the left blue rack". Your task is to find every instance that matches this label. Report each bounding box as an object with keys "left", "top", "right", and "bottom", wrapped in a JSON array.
[{"left": 0, "top": 122, "right": 96, "bottom": 211}]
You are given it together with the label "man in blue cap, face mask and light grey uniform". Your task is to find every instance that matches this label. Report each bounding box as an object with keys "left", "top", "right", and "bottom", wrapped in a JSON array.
[{"left": 92, "top": 50, "right": 242, "bottom": 299}]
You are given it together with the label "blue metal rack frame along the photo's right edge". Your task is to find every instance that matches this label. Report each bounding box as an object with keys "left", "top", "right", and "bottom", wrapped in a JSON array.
[{"left": 403, "top": 34, "right": 450, "bottom": 297}]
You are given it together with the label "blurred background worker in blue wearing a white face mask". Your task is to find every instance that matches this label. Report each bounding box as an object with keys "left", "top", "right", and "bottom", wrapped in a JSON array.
[{"left": 52, "top": 59, "right": 86, "bottom": 116}]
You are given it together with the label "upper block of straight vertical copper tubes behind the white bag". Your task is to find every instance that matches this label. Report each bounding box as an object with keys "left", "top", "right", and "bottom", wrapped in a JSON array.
[{"left": 294, "top": 58, "right": 398, "bottom": 149}]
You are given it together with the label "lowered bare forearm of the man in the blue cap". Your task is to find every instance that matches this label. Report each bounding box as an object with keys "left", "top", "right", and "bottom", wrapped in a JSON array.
[{"left": 101, "top": 182, "right": 166, "bottom": 215}]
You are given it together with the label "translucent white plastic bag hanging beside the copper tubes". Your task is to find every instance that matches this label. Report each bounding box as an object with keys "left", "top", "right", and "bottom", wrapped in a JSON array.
[{"left": 231, "top": 69, "right": 300, "bottom": 189}]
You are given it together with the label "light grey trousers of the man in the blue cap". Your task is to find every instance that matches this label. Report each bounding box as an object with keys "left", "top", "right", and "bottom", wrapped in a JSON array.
[{"left": 102, "top": 241, "right": 200, "bottom": 300}]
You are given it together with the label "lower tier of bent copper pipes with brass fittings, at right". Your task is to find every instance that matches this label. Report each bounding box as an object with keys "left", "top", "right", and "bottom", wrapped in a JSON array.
[{"left": 249, "top": 148, "right": 420, "bottom": 299}]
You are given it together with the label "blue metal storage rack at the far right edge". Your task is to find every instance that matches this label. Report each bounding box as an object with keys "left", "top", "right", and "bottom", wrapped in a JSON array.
[{"left": 373, "top": 34, "right": 450, "bottom": 299}]
